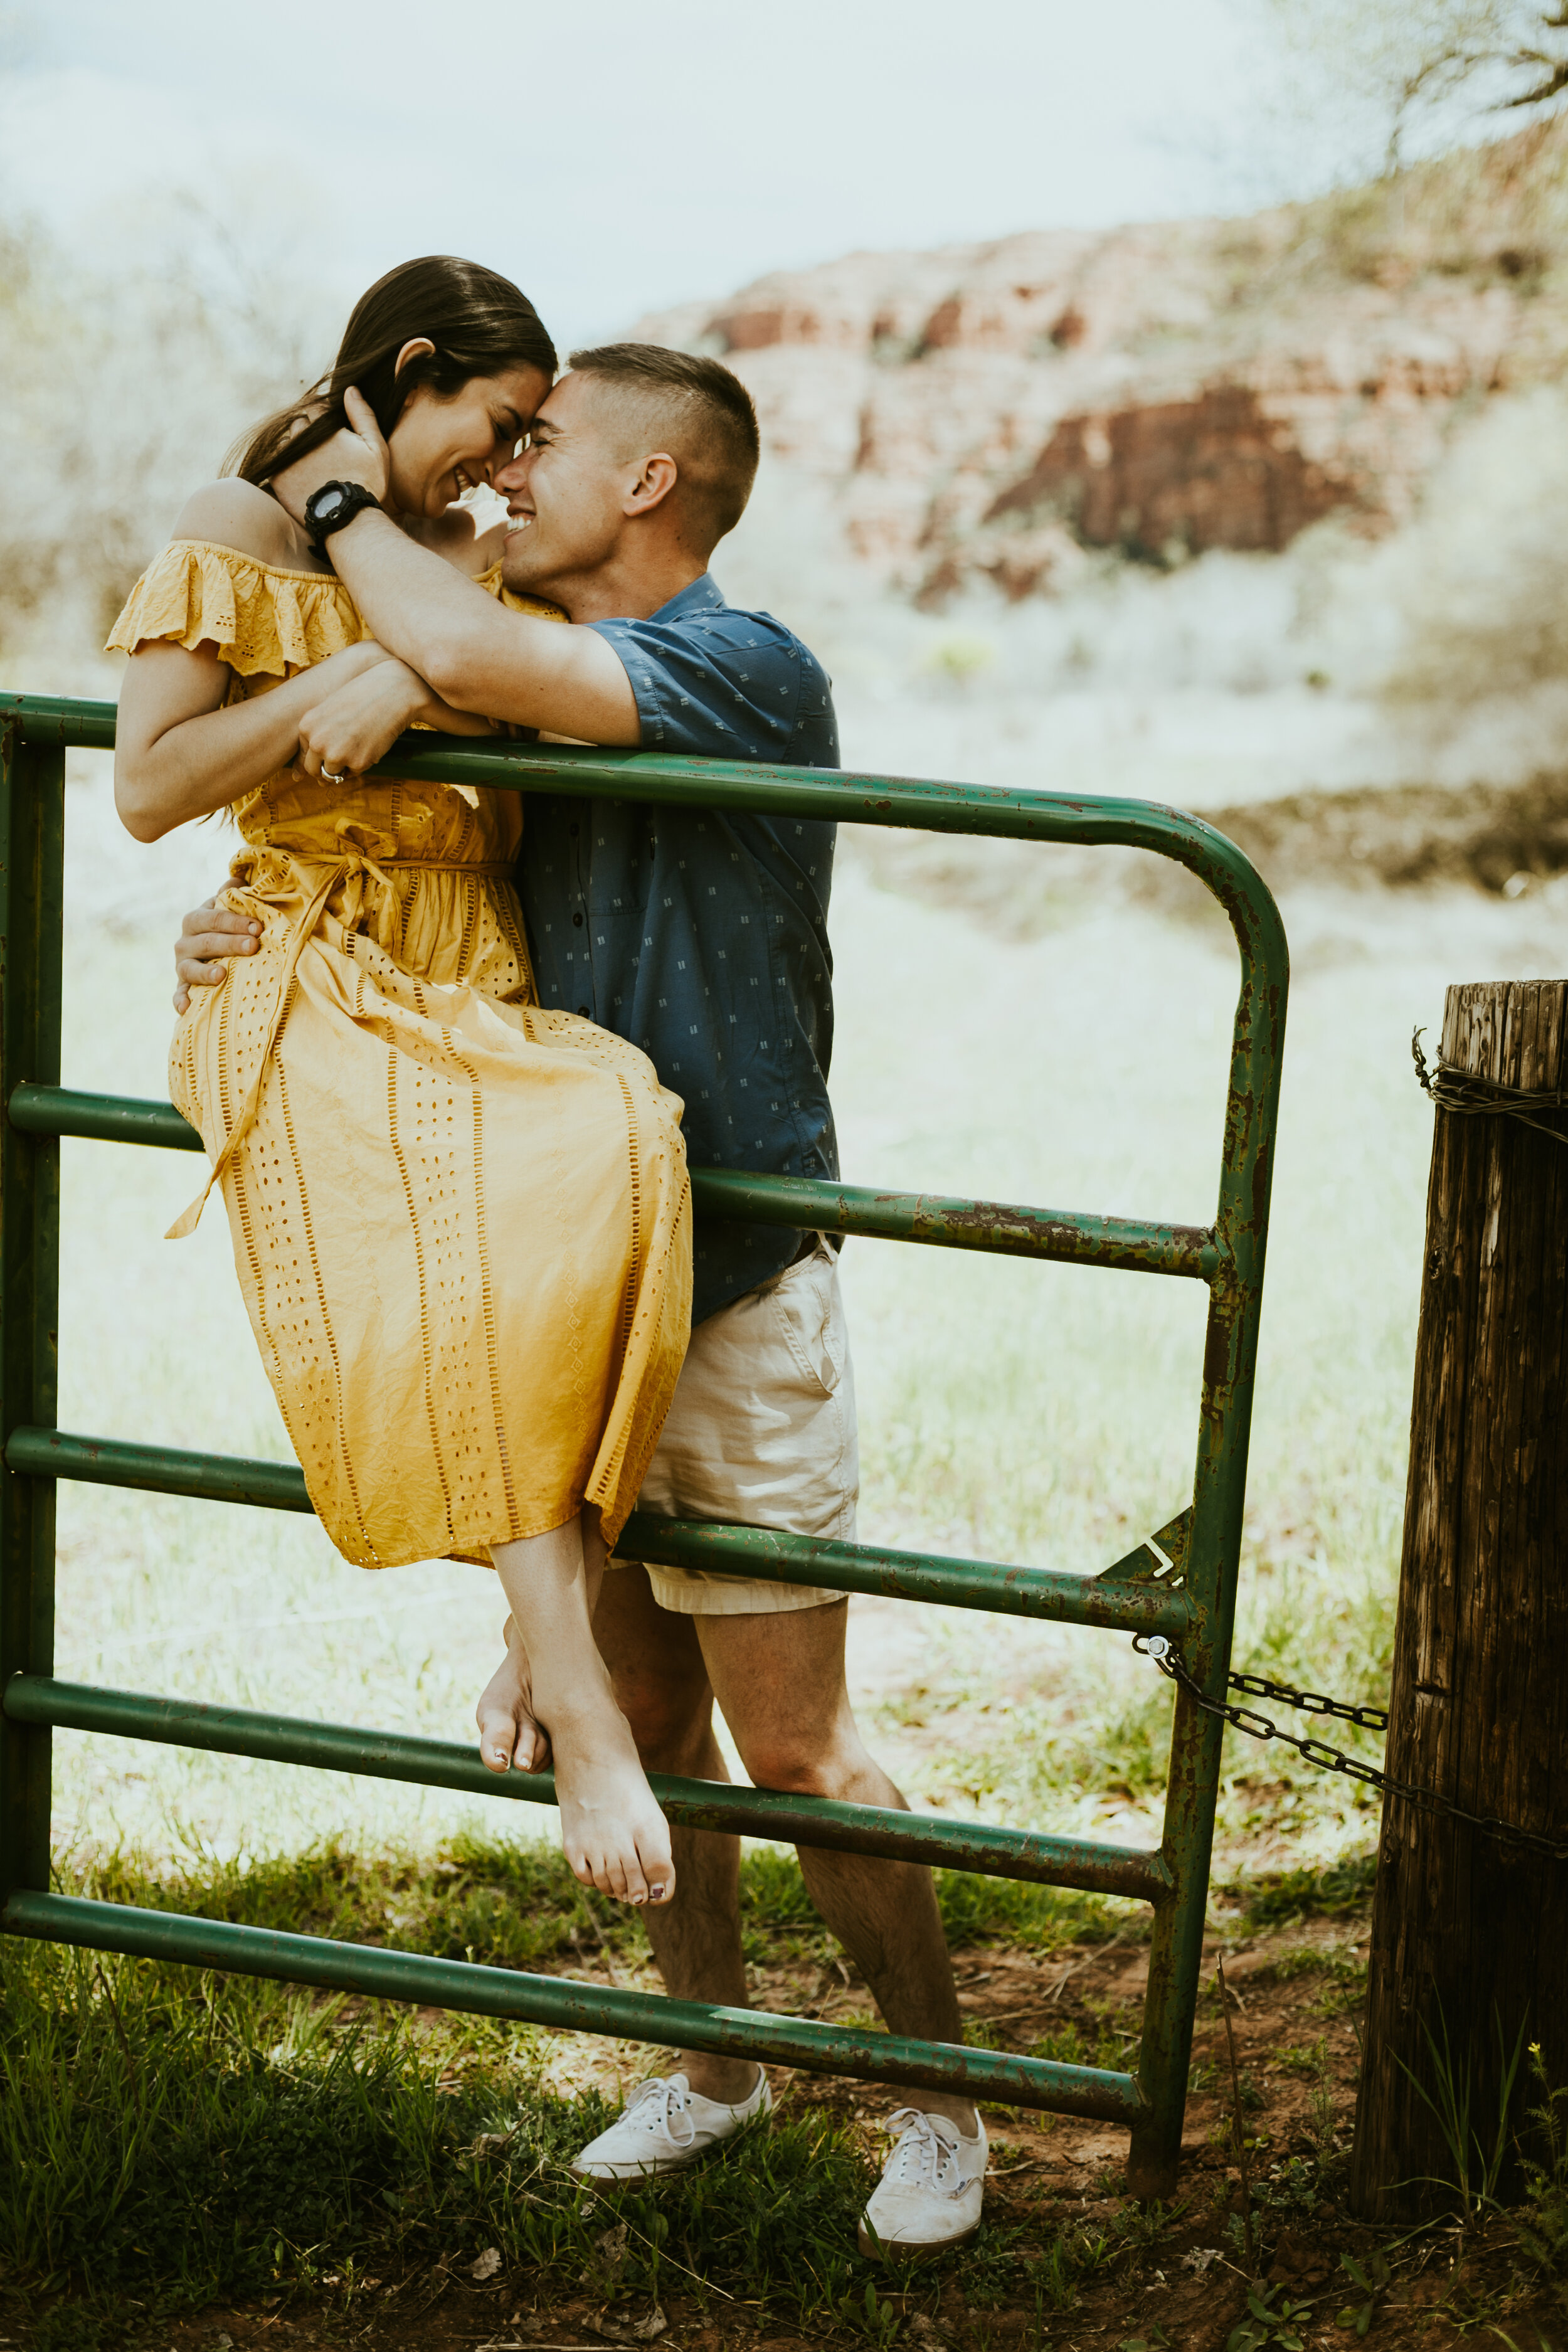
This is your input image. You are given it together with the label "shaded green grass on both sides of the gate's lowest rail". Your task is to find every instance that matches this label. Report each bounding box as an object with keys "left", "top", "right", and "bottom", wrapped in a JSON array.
[{"left": 0, "top": 1840, "right": 1128, "bottom": 2345}]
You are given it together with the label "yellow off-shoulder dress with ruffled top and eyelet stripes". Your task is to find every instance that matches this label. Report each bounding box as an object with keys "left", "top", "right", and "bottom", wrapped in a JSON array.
[{"left": 108, "top": 541, "right": 691, "bottom": 1569}]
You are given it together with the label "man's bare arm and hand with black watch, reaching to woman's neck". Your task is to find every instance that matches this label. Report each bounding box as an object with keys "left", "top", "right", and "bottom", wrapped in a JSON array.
[{"left": 273, "top": 395, "right": 642, "bottom": 743}]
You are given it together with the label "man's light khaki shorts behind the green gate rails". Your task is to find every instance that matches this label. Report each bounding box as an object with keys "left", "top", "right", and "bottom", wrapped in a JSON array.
[{"left": 609, "top": 1237, "right": 861, "bottom": 1616}]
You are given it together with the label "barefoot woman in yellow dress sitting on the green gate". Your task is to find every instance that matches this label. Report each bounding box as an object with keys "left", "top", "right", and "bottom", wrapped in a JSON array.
[{"left": 110, "top": 257, "right": 691, "bottom": 1903}]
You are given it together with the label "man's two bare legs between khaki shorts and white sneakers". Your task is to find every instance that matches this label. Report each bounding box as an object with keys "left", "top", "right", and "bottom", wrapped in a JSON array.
[{"left": 595, "top": 1569, "right": 975, "bottom": 2136}]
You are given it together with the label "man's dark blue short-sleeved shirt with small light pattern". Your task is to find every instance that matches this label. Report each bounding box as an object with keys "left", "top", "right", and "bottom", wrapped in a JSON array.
[{"left": 517, "top": 574, "right": 839, "bottom": 1322}]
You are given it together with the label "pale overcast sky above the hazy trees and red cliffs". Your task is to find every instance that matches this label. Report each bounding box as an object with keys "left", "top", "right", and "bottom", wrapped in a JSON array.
[{"left": 0, "top": 0, "right": 1288, "bottom": 344}]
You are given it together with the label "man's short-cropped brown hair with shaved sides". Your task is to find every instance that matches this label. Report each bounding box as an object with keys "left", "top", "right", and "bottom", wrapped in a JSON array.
[{"left": 571, "top": 344, "right": 761, "bottom": 548}]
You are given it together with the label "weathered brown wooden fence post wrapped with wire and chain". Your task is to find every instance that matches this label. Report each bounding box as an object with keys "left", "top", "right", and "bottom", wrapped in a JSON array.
[{"left": 1352, "top": 981, "right": 1568, "bottom": 2220}]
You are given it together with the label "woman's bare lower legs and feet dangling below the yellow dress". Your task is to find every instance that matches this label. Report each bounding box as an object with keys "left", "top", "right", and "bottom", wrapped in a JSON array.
[{"left": 480, "top": 1520, "right": 675, "bottom": 1903}]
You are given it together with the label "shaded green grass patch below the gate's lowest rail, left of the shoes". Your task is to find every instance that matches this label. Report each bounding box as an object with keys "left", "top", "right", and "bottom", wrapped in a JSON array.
[{"left": 0, "top": 1947, "right": 870, "bottom": 2310}]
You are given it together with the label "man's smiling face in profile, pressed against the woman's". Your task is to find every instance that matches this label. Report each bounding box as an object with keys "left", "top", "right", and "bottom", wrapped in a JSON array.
[{"left": 494, "top": 374, "right": 637, "bottom": 595}]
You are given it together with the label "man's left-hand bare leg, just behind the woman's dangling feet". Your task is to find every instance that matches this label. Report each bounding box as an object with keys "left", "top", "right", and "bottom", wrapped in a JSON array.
[{"left": 593, "top": 1569, "right": 757, "bottom": 2105}]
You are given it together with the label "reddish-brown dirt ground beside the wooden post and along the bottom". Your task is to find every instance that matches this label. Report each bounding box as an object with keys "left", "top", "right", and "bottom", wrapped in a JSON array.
[{"left": 58, "top": 1915, "right": 1542, "bottom": 2352}]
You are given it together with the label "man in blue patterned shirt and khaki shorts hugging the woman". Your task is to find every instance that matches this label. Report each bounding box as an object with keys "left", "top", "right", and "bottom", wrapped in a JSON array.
[{"left": 179, "top": 344, "right": 985, "bottom": 2254}]
